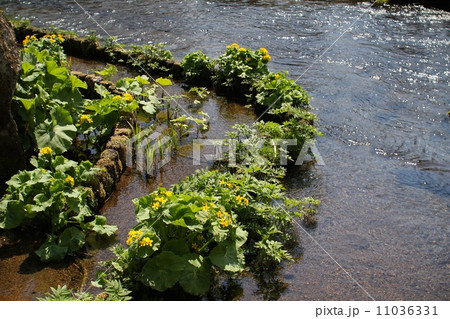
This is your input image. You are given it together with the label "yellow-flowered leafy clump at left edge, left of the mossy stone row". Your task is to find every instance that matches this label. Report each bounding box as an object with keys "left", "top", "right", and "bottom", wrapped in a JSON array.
[{"left": 0, "top": 147, "right": 117, "bottom": 261}]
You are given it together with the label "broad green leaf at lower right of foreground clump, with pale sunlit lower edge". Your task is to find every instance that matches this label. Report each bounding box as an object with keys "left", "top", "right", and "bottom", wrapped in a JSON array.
[{"left": 209, "top": 241, "right": 244, "bottom": 272}]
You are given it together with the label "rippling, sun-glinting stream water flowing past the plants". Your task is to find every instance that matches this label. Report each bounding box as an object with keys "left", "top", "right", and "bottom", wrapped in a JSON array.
[{"left": 0, "top": 0, "right": 450, "bottom": 300}]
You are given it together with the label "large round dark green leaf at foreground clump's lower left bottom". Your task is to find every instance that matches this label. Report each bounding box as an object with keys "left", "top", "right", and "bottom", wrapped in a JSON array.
[{"left": 139, "top": 251, "right": 186, "bottom": 291}]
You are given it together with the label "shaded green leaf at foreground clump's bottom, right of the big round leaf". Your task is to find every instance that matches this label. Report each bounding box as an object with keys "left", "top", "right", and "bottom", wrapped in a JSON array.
[{"left": 180, "top": 254, "right": 211, "bottom": 295}]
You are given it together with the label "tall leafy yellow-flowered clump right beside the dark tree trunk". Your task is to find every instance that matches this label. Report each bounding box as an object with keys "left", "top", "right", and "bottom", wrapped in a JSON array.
[{"left": 11, "top": 35, "right": 87, "bottom": 154}]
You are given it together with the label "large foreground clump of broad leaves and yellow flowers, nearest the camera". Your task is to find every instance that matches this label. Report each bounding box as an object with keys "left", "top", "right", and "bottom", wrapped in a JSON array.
[{"left": 99, "top": 169, "right": 318, "bottom": 295}]
